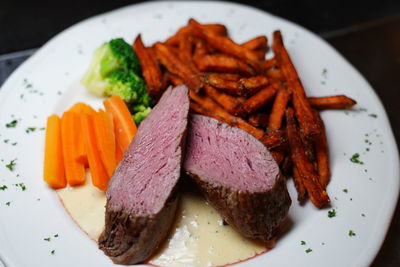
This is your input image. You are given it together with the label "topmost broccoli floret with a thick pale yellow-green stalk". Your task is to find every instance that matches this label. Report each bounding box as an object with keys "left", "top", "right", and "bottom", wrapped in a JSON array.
[{"left": 82, "top": 38, "right": 140, "bottom": 96}]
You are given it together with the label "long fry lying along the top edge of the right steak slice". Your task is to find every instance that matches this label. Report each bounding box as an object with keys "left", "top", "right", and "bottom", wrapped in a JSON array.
[{"left": 189, "top": 91, "right": 266, "bottom": 141}]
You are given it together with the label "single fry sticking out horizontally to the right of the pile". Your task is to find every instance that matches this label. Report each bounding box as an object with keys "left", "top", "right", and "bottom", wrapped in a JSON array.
[{"left": 308, "top": 95, "right": 357, "bottom": 109}]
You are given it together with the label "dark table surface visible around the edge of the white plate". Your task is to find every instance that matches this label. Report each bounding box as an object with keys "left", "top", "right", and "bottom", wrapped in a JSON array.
[{"left": 0, "top": 0, "right": 400, "bottom": 267}]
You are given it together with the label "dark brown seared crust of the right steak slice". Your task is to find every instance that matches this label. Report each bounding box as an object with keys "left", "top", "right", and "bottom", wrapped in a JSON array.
[{"left": 188, "top": 173, "right": 292, "bottom": 242}]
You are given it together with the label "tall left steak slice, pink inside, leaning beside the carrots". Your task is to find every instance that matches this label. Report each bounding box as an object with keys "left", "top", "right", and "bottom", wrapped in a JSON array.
[{"left": 98, "top": 86, "right": 189, "bottom": 264}]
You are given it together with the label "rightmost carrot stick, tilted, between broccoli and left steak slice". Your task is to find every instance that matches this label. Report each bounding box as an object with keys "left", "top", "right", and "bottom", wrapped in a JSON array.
[{"left": 103, "top": 96, "right": 137, "bottom": 152}]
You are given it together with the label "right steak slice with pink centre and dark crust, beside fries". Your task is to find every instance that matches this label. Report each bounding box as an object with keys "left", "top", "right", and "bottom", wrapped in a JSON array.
[{"left": 184, "top": 115, "right": 291, "bottom": 242}]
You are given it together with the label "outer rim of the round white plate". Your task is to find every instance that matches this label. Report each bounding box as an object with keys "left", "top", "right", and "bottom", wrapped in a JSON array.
[{"left": 0, "top": 1, "right": 400, "bottom": 266}]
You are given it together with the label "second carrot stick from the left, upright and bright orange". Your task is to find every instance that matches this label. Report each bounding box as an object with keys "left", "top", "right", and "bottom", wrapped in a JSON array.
[{"left": 61, "top": 111, "right": 85, "bottom": 186}]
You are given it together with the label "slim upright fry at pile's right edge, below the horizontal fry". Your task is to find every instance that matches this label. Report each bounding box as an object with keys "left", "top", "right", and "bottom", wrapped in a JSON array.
[{"left": 314, "top": 111, "right": 331, "bottom": 188}]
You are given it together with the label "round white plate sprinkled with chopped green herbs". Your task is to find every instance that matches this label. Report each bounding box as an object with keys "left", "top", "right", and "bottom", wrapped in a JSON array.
[{"left": 0, "top": 2, "right": 399, "bottom": 267}]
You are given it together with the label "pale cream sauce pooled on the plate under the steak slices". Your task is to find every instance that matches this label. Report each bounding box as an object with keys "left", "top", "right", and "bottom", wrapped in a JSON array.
[{"left": 57, "top": 175, "right": 267, "bottom": 267}]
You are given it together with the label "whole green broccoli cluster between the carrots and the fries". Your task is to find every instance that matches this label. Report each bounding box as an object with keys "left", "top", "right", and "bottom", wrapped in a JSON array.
[{"left": 82, "top": 38, "right": 153, "bottom": 124}]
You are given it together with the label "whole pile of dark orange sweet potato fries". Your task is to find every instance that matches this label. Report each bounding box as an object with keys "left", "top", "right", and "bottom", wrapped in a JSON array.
[{"left": 133, "top": 19, "right": 356, "bottom": 208}]
